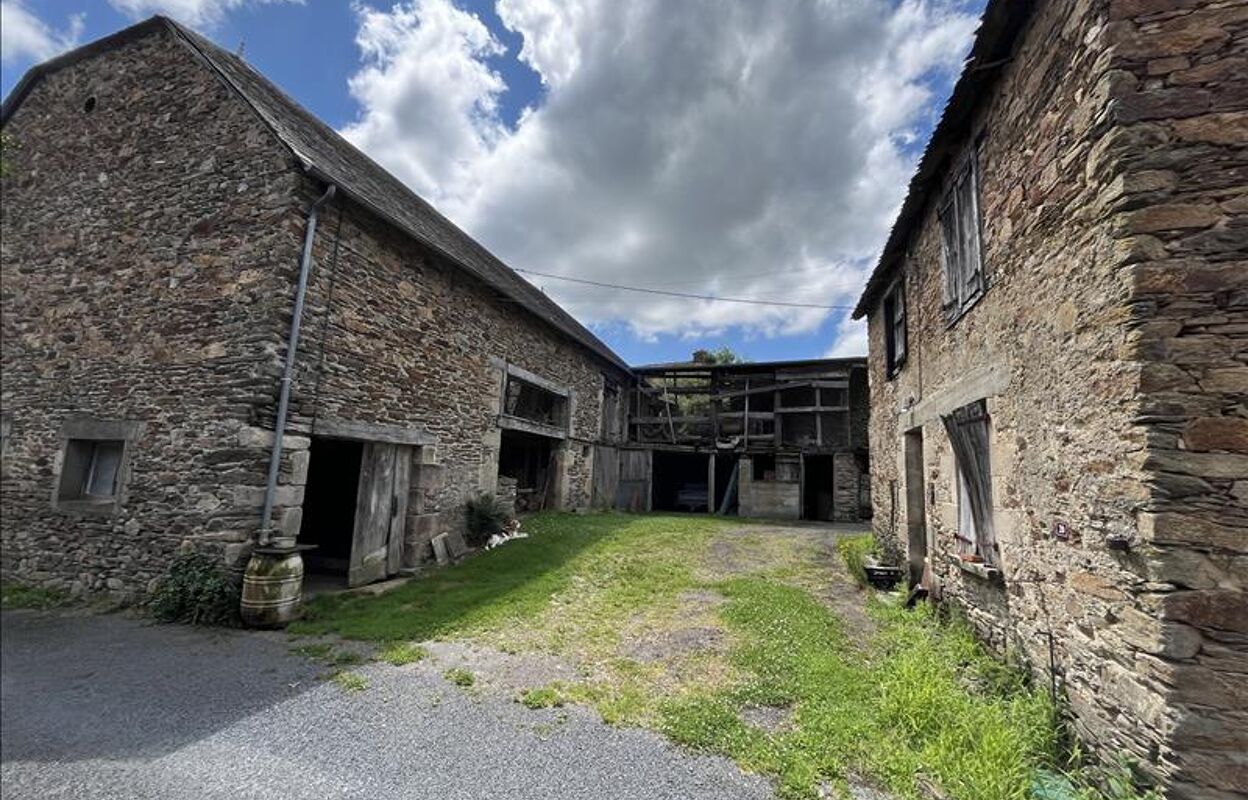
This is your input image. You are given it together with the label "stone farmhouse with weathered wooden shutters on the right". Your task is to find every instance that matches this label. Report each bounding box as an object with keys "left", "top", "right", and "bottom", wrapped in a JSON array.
[{"left": 855, "top": 0, "right": 1248, "bottom": 800}]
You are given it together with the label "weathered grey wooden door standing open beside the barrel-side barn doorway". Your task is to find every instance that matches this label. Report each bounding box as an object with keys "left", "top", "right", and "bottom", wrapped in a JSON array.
[{"left": 347, "top": 442, "right": 412, "bottom": 587}]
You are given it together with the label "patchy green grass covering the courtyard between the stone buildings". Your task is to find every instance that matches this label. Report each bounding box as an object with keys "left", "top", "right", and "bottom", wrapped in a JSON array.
[{"left": 292, "top": 514, "right": 1138, "bottom": 800}]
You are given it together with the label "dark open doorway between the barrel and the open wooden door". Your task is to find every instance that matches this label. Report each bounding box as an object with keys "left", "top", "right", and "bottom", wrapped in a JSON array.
[{"left": 300, "top": 437, "right": 364, "bottom": 575}]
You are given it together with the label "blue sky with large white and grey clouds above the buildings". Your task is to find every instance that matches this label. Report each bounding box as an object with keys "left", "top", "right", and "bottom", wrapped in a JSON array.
[{"left": 0, "top": 0, "right": 983, "bottom": 363}]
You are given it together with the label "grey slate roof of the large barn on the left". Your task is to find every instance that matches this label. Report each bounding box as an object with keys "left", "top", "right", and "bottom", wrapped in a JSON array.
[{"left": 0, "top": 16, "right": 628, "bottom": 371}]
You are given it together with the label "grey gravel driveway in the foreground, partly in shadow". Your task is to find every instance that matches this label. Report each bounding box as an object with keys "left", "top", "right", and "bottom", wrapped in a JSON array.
[{"left": 0, "top": 612, "right": 771, "bottom": 800}]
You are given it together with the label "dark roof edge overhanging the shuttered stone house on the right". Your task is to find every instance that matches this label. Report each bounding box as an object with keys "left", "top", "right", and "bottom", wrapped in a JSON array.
[{"left": 851, "top": 0, "right": 1035, "bottom": 320}]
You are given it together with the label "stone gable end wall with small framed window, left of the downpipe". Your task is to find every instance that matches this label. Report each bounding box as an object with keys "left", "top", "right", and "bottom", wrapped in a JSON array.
[{"left": 0, "top": 32, "right": 300, "bottom": 593}]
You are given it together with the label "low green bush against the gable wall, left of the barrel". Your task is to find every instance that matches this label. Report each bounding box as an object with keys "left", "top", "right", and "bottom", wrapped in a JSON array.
[{"left": 149, "top": 552, "right": 240, "bottom": 627}]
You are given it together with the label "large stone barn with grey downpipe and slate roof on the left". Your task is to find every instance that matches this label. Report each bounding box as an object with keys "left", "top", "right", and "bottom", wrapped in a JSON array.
[{"left": 0, "top": 17, "right": 631, "bottom": 595}]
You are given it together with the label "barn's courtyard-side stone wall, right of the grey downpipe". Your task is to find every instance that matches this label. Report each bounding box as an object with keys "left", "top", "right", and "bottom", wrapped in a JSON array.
[{"left": 291, "top": 186, "right": 626, "bottom": 554}]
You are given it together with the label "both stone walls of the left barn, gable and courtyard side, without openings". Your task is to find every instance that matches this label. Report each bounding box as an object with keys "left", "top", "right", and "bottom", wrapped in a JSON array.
[{"left": 0, "top": 27, "right": 625, "bottom": 597}]
